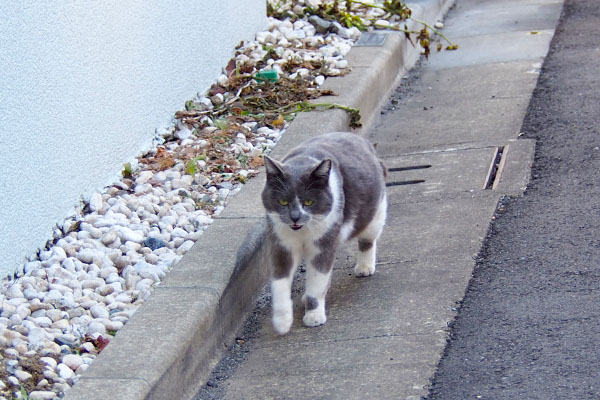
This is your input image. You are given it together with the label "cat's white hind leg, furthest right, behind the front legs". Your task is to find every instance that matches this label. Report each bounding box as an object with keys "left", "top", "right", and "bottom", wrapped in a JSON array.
[{"left": 354, "top": 196, "right": 387, "bottom": 276}]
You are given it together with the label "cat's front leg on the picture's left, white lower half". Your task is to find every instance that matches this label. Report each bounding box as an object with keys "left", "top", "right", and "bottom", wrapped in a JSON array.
[{"left": 271, "top": 246, "right": 298, "bottom": 335}]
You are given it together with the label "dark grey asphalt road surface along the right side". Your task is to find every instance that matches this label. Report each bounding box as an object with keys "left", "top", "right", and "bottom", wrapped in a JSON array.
[{"left": 428, "top": 0, "right": 600, "bottom": 400}]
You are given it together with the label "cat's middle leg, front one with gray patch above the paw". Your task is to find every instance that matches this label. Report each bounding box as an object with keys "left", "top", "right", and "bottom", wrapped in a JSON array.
[{"left": 302, "top": 248, "right": 335, "bottom": 327}]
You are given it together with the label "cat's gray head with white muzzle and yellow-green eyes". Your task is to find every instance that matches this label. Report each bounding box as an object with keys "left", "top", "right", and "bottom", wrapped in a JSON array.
[{"left": 262, "top": 156, "right": 333, "bottom": 230}]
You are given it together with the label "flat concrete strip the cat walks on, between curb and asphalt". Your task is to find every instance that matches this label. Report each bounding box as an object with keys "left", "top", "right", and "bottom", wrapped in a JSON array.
[{"left": 196, "top": 0, "right": 562, "bottom": 399}]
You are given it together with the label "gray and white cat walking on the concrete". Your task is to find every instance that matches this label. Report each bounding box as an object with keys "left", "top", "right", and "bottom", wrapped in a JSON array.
[{"left": 262, "top": 132, "right": 387, "bottom": 335}]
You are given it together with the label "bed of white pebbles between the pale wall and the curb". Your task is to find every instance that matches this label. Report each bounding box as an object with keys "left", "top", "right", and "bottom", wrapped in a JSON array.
[{"left": 0, "top": 0, "right": 436, "bottom": 399}]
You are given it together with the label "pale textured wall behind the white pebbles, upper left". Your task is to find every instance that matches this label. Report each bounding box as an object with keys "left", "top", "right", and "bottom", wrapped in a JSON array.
[{"left": 0, "top": 0, "right": 266, "bottom": 276}]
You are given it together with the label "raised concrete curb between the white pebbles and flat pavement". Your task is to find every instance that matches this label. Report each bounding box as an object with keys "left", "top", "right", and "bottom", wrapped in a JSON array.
[{"left": 66, "top": 0, "right": 453, "bottom": 400}]
